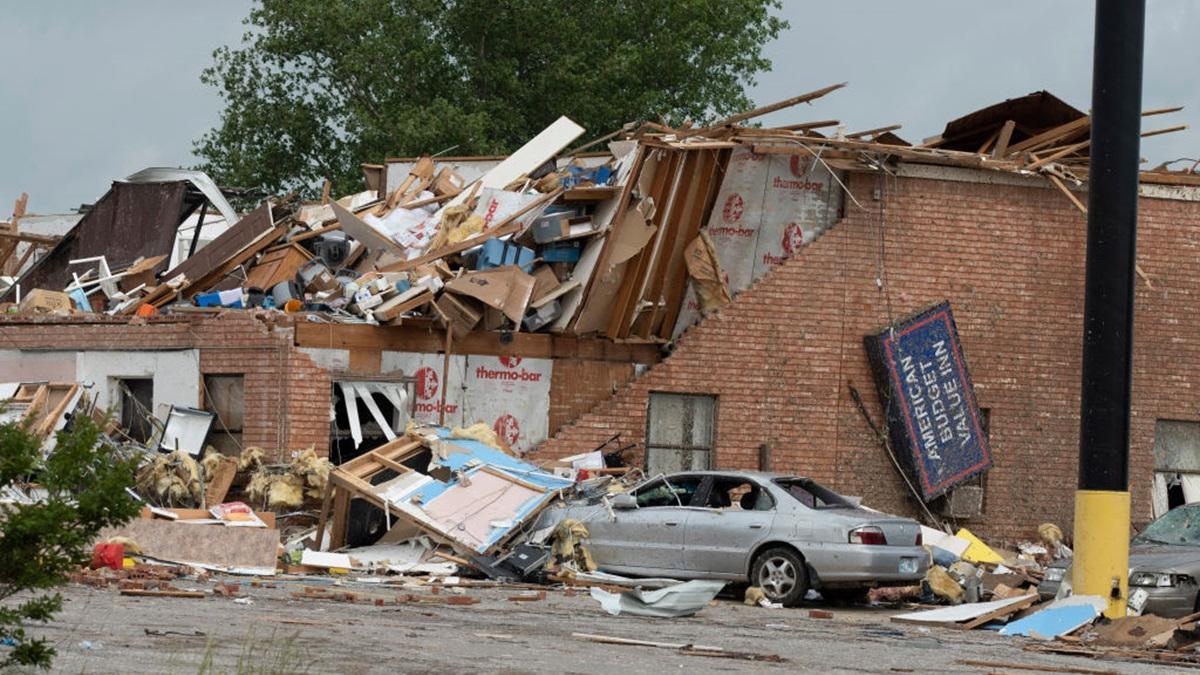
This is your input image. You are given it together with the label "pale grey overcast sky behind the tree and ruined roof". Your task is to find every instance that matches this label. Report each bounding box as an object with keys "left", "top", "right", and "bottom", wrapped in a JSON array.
[{"left": 0, "top": 0, "right": 1200, "bottom": 211}]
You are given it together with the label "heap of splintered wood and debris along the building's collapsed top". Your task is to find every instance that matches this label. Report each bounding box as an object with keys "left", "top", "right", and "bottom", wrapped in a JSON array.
[{"left": 9, "top": 84, "right": 1180, "bottom": 342}]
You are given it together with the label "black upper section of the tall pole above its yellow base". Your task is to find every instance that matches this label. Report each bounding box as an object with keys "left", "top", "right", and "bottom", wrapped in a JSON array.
[{"left": 1079, "top": 0, "right": 1146, "bottom": 491}]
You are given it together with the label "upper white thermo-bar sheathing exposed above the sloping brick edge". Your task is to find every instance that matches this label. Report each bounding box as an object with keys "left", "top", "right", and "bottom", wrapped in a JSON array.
[{"left": 676, "top": 145, "right": 841, "bottom": 335}]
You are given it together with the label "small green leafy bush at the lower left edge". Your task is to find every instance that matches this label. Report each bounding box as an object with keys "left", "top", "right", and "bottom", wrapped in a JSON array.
[{"left": 0, "top": 416, "right": 138, "bottom": 669}]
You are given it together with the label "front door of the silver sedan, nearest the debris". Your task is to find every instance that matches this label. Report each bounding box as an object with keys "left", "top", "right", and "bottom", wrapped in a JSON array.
[{"left": 588, "top": 476, "right": 702, "bottom": 574}]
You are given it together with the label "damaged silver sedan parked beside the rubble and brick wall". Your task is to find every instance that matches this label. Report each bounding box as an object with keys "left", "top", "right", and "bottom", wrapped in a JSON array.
[{"left": 546, "top": 471, "right": 929, "bottom": 605}]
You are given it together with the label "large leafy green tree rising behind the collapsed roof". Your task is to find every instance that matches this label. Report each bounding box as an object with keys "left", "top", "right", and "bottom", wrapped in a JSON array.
[{"left": 196, "top": 0, "right": 787, "bottom": 195}]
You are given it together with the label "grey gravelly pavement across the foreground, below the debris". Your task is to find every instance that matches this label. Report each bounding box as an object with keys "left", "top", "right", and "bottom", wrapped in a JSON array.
[{"left": 14, "top": 571, "right": 1180, "bottom": 674}]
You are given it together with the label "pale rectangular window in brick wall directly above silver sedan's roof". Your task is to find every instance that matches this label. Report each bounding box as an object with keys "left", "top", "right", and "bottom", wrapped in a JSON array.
[{"left": 646, "top": 393, "right": 716, "bottom": 474}]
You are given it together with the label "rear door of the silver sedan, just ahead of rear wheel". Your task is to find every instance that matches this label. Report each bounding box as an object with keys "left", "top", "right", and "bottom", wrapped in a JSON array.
[{"left": 683, "top": 476, "right": 775, "bottom": 571}]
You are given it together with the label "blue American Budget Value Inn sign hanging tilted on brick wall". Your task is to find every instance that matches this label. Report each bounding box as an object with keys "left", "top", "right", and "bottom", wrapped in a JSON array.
[{"left": 863, "top": 303, "right": 991, "bottom": 501}]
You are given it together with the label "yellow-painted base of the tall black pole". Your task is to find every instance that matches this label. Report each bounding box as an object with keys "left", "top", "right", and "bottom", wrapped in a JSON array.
[{"left": 1070, "top": 490, "right": 1130, "bottom": 619}]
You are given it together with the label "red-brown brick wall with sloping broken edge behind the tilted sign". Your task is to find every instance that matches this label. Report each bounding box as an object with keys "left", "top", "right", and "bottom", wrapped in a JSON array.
[{"left": 535, "top": 174, "right": 1200, "bottom": 539}]
